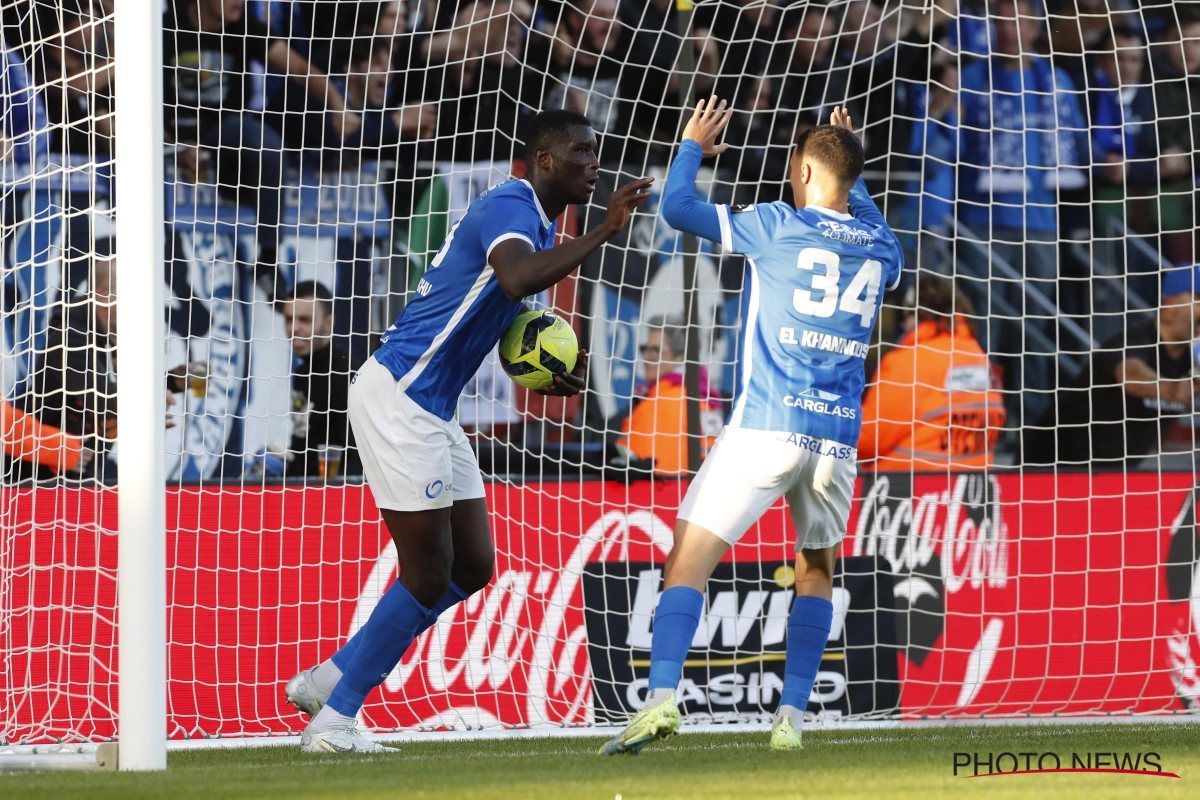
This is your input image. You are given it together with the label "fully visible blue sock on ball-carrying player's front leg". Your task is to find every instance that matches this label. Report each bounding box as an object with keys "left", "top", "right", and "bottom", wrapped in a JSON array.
[{"left": 329, "top": 581, "right": 430, "bottom": 717}]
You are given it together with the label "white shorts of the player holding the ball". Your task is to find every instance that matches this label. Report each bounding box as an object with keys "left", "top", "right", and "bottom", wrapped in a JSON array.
[{"left": 349, "top": 359, "right": 484, "bottom": 511}]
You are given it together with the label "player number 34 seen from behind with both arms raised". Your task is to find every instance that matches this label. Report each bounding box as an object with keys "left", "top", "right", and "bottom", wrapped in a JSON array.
[{"left": 600, "top": 97, "right": 902, "bottom": 756}]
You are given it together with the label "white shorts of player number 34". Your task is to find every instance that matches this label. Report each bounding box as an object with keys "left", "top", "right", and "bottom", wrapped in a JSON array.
[{"left": 679, "top": 428, "right": 858, "bottom": 551}]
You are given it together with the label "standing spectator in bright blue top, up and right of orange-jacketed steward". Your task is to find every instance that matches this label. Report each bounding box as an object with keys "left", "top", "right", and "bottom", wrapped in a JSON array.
[{"left": 958, "top": 0, "right": 1087, "bottom": 422}]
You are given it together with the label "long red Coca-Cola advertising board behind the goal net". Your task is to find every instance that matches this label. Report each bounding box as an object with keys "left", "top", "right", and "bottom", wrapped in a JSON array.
[{"left": 0, "top": 473, "right": 1200, "bottom": 742}]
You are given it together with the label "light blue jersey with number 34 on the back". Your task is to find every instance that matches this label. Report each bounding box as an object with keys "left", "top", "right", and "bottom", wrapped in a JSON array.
[{"left": 716, "top": 181, "right": 904, "bottom": 446}]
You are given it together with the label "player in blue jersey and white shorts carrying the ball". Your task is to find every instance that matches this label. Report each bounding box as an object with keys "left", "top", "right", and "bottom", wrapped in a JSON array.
[{"left": 284, "top": 110, "right": 652, "bottom": 752}]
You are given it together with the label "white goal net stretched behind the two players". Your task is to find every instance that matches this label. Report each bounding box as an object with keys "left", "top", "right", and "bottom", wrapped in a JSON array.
[{"left": 0, "top": 0, "right": 1200, "bottom": 745}]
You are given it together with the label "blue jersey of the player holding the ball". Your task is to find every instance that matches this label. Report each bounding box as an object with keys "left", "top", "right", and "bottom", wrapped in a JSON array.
[{"left": 374, "top": 180, "right": 554, "bottom": 420}]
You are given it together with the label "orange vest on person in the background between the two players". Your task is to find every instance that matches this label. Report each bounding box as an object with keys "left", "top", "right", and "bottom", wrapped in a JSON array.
[{"left": 622, "top": 380, "right": 722, "bottom": 475}]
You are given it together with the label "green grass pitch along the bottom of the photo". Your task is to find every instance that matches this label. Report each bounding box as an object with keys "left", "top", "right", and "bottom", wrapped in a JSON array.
[{"left": 0, "top": 723, "right": 1200, "bottom": 800}]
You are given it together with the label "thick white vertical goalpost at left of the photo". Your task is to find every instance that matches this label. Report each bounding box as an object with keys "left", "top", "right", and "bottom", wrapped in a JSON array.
[{"left": 114, "top": 0, "right": 167, "bottom": 770}]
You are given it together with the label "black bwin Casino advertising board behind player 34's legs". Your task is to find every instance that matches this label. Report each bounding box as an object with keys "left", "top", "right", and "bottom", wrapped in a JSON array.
[{"left": 583, "top": 561, "right": 900, "bottom": 722}]
